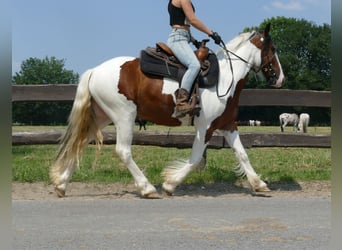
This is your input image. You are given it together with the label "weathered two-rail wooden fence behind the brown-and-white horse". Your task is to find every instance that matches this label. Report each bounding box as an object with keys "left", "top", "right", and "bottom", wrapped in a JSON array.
[{"left": 12, "top": 84, "right": 331, "bottom": 148}]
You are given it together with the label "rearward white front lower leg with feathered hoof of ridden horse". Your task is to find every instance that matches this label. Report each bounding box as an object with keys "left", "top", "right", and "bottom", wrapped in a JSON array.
[{"left": 162, "top": 131, "right": 207, "bottom": 195}]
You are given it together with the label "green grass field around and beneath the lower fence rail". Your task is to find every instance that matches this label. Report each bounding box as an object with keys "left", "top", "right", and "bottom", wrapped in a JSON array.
[{"left": 12, "top": 126, "right": 331, "bottom": 185}]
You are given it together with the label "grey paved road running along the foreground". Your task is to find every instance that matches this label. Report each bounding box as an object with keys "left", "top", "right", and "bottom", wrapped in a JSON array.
[{"left": 12, "top": 197, "right": 331, "bottom": 250}]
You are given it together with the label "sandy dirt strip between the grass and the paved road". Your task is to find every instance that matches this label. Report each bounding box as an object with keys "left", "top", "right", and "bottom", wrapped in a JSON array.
[{"left": 12, "top": 181, "right": 331, "bottom": 200}]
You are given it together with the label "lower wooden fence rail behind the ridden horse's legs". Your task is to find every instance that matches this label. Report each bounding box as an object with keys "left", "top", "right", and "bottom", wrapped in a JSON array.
[{"left": 12, "top": 130, "right": 331, "bottom": 148}]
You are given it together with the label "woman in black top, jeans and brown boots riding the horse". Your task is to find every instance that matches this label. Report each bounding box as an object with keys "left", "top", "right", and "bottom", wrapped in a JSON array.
[{"left": 167, "top": 0, "right": 221, "bottom": 117}]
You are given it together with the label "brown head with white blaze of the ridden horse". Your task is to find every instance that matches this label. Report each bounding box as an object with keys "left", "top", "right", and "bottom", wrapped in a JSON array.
[{"left": 250, "top": 24, "right": 285, "bottom": 88}]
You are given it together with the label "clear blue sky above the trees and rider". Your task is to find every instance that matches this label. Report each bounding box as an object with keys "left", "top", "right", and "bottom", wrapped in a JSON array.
[{"left": 11, "top": 0, "right": 331, "bottom": 74}]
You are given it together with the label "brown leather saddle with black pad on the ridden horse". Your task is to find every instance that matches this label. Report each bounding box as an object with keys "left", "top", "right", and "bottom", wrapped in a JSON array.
[{"left": 140, "top": 39, "right": 219, "bottom": 88}]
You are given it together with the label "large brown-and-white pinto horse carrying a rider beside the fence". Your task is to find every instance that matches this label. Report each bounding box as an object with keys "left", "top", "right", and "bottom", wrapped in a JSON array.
[{"left": 50, "top": 25, "right": 285, "bottom": 198}]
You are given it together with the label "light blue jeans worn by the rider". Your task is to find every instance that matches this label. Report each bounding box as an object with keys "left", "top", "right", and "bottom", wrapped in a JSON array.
[{"left": 167, "top": 29, "right": 201, "bottom": 92}]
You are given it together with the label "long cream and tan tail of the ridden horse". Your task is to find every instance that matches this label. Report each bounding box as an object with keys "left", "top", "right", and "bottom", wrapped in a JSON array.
[{"left": 50, "top": 70, "right": 103, "bottom": 186}]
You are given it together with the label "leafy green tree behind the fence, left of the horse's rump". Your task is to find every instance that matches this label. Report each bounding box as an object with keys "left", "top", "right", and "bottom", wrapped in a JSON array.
[{"left": 12, "top": 57, "right": 79, "bottom": 125}]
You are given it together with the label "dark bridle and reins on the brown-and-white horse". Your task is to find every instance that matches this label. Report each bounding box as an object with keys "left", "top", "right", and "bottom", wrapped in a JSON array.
[{"left": 216, "top": 32, "right": 278, "bottom": 98}]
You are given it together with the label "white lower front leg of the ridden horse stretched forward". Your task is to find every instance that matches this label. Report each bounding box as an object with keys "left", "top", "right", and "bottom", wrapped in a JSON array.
[{"left": 221, "top": 130, "right": 270, "bottom": 192}]
